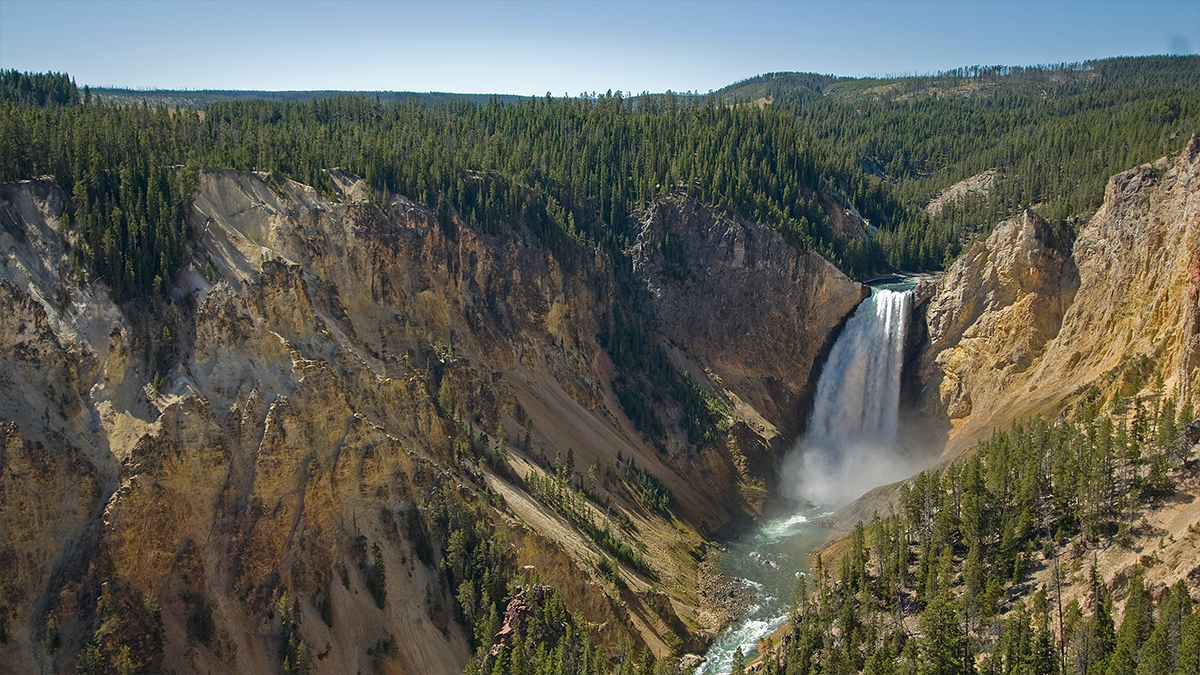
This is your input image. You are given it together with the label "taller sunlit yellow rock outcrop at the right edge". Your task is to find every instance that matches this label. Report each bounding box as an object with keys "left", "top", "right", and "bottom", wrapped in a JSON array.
[{"left": 1030, "top": 142, "right": 1200, "bottom": 402}]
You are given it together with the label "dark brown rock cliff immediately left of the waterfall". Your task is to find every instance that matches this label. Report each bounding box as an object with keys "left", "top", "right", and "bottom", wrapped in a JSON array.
[{"left": 634, "top": 194, "right": 869, "bottom": 440}]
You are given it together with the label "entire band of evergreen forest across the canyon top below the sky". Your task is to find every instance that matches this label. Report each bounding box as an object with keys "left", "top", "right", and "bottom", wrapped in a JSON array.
[{"left": 0, "top": 56, "right": 1200, "bottom": 291}]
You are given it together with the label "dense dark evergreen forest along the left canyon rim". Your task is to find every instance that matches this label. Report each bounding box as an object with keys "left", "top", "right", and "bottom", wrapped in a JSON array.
[{"left": 2, "top": 75, "right": 864, "bottom": 279}]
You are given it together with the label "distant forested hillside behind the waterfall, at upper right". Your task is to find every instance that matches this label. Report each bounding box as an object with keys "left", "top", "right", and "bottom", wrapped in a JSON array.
[{"left": 718, "top": 56, "right": 1200, "bottom": 269}]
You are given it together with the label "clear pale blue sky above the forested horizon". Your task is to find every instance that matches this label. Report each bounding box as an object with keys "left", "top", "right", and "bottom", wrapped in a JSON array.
[{"left": 0, "top": 0, "right": 1200, "bottom": 96}]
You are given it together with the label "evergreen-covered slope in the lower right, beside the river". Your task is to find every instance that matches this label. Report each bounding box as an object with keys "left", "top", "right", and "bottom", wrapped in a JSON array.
[{"left": 736, "top": 387, "right": 1200, "bottom": 675}]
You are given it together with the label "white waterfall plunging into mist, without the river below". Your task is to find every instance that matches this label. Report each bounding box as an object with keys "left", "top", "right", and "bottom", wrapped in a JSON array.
[{"left": 784, "top": 289, "right": 912, "bottom": 506}]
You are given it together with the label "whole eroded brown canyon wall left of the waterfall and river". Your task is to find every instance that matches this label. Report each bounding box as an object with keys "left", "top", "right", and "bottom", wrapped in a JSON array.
[{"left": 0, "top": 169, "right": 863, "bottom": 675}]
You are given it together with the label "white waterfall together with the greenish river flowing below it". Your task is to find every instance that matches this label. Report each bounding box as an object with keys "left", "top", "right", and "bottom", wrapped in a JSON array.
[{"left": 696, "top": 288, "right": 912, "bottom": 675}]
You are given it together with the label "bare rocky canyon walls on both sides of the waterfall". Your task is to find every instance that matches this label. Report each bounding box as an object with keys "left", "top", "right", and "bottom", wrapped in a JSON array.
[{"left": 0, "top": 127, "right": 1200, "bottom": 675}]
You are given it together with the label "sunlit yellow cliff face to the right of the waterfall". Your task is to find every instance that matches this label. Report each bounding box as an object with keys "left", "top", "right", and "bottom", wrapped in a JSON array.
[{"left": 918, "top": 138, "right": 1200, "bottom": 454}]
